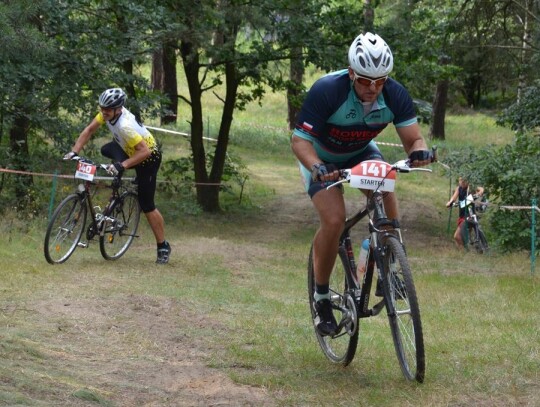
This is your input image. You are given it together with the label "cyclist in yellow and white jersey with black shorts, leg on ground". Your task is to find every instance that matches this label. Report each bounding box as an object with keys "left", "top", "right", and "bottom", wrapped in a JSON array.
[{"left": 64, "top": 88, "right": 171, "bottom": 264}]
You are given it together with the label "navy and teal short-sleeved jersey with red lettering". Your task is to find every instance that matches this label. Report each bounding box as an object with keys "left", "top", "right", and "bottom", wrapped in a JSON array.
[{"left": 293, "top": 69, "right": 417, "bottom": 163}]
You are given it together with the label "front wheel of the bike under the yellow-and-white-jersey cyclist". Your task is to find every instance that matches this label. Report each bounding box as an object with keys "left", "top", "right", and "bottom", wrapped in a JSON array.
[{"left": 43, "top": 194, "right": 88, "bottom": 264}]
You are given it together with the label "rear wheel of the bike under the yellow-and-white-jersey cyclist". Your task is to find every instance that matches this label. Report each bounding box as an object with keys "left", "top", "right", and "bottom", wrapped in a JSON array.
[{"left": 99, "top": 191, "right": 141, "bottom": 260}]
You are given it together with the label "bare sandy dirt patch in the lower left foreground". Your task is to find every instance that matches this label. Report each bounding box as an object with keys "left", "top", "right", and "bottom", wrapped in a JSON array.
[{"left": 37, "top": 295, "right": 274, "bottom": 406}]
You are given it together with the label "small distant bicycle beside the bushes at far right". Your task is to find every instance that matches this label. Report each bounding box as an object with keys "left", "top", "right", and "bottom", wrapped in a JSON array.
[{"left": 452, "top": 194, "right": 489, "bottom": 254}]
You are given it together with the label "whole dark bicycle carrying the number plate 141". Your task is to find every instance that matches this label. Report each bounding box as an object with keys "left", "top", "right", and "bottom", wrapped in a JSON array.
[{"left": 308, "top": 155, "right": 435, "bottom": 382}]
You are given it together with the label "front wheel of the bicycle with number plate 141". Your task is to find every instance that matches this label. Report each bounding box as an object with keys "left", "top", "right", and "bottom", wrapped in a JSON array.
[{"left": 381, "top": 236, "right": 425, "bottom": 383}]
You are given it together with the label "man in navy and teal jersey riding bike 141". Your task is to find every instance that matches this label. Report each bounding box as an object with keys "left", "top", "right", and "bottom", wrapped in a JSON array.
[{"left": 291, "top": 32, "right": 432, "bottom": 335}]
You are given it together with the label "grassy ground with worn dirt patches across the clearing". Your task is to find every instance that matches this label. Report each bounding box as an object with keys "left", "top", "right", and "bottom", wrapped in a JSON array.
[{"left": 0, "top": 81, "right": 540, "bottom": 406}]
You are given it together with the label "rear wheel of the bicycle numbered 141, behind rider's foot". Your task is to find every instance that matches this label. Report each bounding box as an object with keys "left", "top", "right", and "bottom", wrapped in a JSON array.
[{"left": 308, "top": 245, "right": 359, "bottom": 366}]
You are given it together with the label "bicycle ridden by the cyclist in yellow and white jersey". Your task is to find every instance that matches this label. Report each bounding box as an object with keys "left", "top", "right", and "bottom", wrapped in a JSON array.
[{"left": 43, "top": 156, "right": 141, "bottom": 264}]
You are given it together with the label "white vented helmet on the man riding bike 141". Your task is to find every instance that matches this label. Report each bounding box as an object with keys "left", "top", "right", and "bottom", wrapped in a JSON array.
[{"left": 349, "top": 32, "right": 394, "bottom": 78}]
